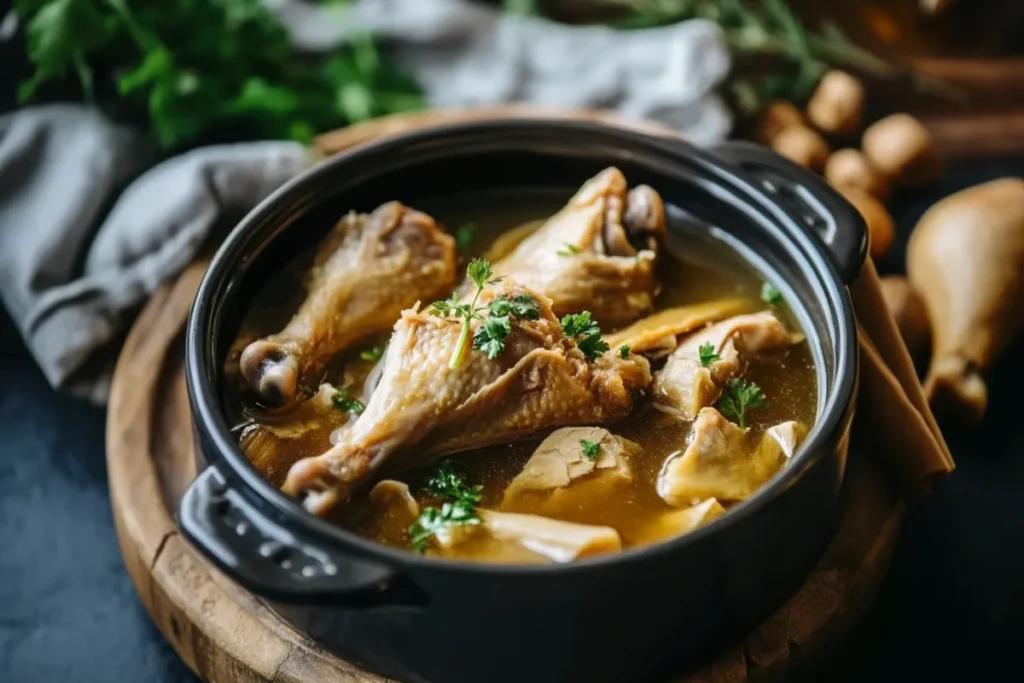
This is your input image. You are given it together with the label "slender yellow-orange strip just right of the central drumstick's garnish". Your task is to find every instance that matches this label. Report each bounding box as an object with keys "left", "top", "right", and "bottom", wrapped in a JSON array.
[{"left": 604, "top": 299, "right": 764, "bottom": 358}]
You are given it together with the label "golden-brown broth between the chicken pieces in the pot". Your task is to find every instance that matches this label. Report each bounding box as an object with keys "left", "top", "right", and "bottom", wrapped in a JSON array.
[{"left": 228, "top": 185, "right": 817, "bottom": 548}]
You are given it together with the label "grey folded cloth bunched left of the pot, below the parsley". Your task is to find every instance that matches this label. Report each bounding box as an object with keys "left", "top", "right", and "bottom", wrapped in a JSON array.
[{"left": 0, "top": 106, "right": 312, "bottom": 401}]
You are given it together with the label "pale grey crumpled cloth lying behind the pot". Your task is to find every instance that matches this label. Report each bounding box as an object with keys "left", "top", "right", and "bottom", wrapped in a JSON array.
[{"left": 267, "top": 0, "right": 732, "bottom": 143}]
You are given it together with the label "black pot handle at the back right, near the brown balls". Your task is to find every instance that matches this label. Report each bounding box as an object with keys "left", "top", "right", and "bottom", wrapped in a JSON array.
[{"left": 712, "top": 140, "right": 867, "bottom": 285}]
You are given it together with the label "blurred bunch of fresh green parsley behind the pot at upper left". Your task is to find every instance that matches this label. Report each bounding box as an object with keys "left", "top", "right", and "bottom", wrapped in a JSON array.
[{"left": 14, "top": 0, "right": 423, "bottom": 148}]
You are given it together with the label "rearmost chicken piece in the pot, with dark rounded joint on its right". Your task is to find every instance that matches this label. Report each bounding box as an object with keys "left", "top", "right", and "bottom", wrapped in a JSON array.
[{"left": 494, "top": 168, "right": 665, "bottom": 329}]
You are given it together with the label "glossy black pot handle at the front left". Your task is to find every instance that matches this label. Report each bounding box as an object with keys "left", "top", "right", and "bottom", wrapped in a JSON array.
[{"left": 178, "top": 465, "right": 396, "bottom": 605}]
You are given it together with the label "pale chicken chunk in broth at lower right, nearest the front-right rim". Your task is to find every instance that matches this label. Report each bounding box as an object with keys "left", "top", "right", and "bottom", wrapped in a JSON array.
[{"left": 657, "top": 408, "right": 806, "bottom": 507}]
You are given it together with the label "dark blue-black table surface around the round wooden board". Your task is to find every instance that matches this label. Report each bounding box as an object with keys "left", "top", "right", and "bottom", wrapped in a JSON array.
[{"left": 0, "top": 159, "right": 1024, "bottom": 683}]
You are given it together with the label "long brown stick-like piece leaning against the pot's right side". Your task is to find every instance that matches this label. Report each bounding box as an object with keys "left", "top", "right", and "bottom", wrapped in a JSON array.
[{"left": 850, "top": 258, "right": 954, "bottom": 495}]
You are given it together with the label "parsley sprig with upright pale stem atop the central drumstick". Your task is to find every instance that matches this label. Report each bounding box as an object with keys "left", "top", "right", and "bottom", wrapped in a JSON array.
[{"left": 431, "top": 258, "right": 541, "bottom": 368}]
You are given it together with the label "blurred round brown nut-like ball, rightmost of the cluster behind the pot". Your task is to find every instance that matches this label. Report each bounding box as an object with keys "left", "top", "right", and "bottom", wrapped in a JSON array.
[{"left": 861, "top": 114, "right": 942, "bottom": 187}]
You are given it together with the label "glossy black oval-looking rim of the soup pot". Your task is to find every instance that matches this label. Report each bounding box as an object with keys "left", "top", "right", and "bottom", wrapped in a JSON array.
[{"left": 185, "top": 117, "right": 858, "bottom": 579}]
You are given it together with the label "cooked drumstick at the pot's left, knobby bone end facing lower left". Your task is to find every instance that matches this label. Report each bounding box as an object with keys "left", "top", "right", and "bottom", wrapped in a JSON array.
[{"left": 240, "top": 202, "right": 457, "bottom": 407}]
